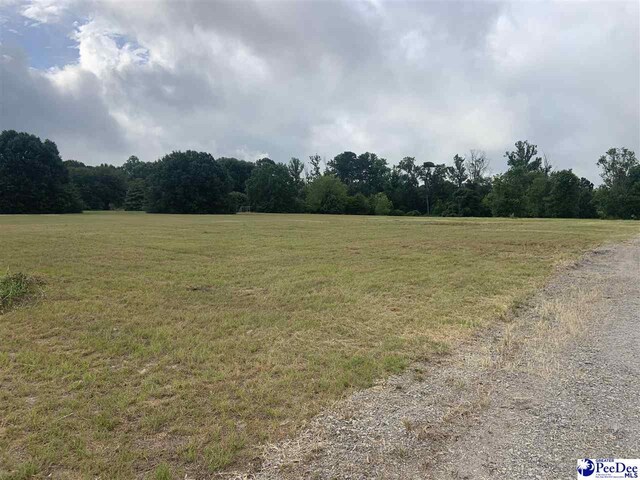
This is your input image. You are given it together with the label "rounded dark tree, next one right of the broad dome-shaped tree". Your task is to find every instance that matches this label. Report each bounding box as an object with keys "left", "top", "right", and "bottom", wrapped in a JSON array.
[{"left": 247, "top": 158, "right": 301, "bottom": 212}]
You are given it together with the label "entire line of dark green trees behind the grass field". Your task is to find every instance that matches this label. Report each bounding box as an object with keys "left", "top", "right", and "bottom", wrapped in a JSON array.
[{"left": 0, "top": 130, "right": 640, "bottom": 219}]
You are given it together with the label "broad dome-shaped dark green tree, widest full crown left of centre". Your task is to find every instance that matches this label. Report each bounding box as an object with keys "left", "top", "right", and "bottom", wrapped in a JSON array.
[{"left": 147, "top": 150, "right": 231, "bottom": 213}]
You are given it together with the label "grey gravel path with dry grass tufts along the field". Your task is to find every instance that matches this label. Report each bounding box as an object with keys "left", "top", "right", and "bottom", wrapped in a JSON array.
[{"left": 242, "top": 239, "right": 640, "bottom": 480}]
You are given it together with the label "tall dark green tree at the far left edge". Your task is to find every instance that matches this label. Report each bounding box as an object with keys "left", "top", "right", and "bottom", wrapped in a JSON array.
[{"left": 0, "top": 130, "right": 82, "bottom": 213}]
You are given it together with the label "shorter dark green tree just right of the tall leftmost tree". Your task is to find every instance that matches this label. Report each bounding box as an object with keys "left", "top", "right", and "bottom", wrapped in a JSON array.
[{"left": 65, "top": 161, "right": 128, "bottom": 210}]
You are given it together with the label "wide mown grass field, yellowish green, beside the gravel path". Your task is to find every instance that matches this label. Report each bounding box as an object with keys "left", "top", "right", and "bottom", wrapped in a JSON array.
[{"left": 0, "top": 213, "right": 640, "bottom": 479}]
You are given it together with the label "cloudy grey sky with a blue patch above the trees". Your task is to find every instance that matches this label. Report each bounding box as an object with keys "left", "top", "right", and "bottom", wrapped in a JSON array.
[{"left": 0, "top": 0, "right": 640, "bottom": 183}]
